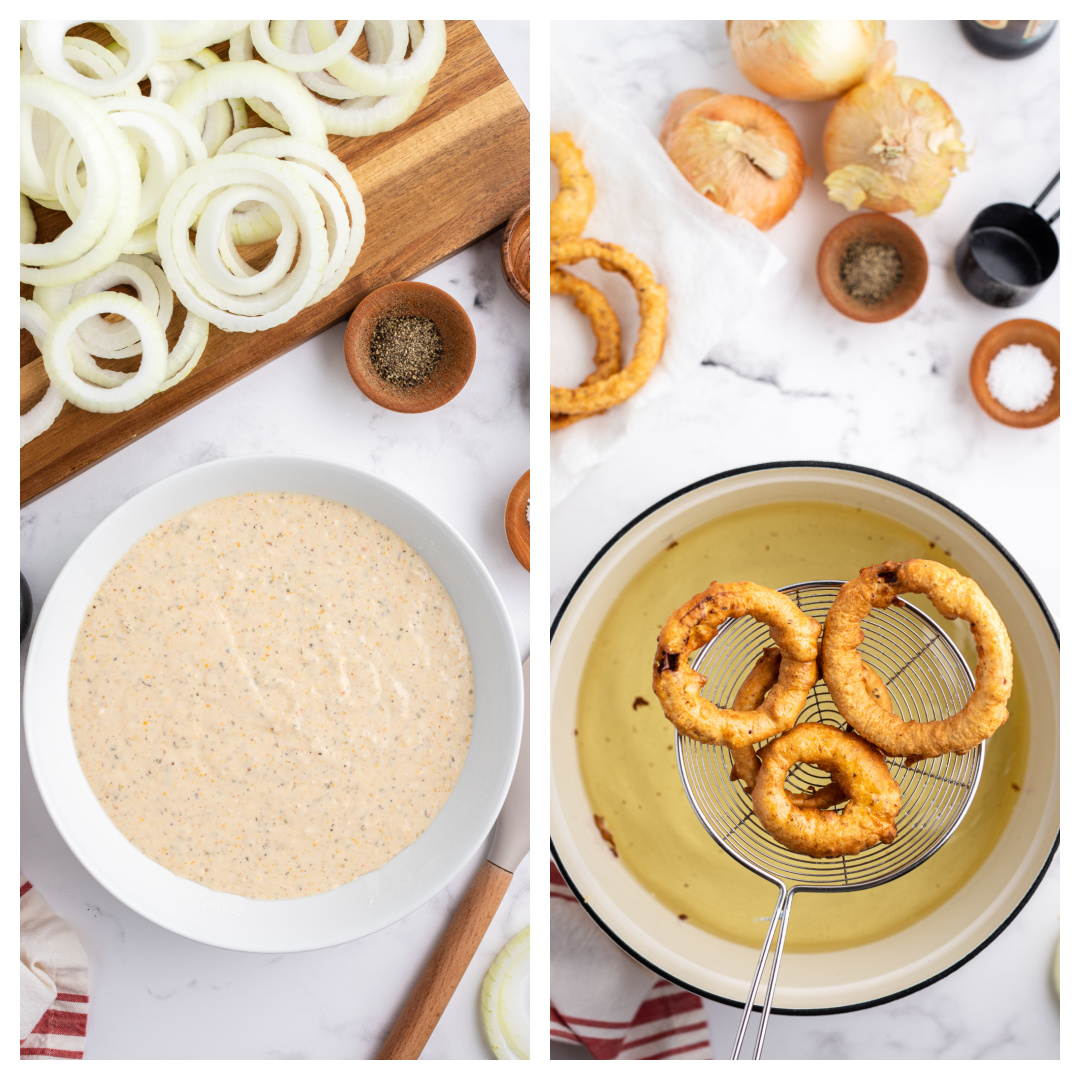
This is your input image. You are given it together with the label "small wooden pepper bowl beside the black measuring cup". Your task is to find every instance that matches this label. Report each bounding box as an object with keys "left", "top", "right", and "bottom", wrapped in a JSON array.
[{"left": 818, "top": 214, "right": 928, "bottom": 323}]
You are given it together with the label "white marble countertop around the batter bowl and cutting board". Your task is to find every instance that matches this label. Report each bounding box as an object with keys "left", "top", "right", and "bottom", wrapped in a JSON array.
[{"left": 21, "top": 23, "right": 529, "bottom": 1058}]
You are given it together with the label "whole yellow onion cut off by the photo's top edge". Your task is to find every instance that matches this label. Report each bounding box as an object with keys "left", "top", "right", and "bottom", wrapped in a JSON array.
[{"left": 728, "top": 18, "right": 885, "bottom": 102}]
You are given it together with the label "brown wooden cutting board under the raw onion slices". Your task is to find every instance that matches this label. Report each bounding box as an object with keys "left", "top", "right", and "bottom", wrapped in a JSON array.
[{"left": 21, "top": 22, "right": 529, "bottom": 504}]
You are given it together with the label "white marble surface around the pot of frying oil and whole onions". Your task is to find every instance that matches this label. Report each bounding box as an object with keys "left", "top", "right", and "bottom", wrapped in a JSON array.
[{"left": 551, "top": 22, "right": 1061, "bottom": 1058}]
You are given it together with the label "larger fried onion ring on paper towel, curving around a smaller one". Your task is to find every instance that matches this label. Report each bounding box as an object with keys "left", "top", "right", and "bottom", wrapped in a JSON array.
[{"left": 551, "top": 238, "right": 667, "bottom": 416}]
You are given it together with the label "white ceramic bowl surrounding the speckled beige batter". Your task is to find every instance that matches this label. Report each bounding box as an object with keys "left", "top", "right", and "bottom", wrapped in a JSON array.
[{"left": 23, "top": 456, "right": 523, "bottom": 953}]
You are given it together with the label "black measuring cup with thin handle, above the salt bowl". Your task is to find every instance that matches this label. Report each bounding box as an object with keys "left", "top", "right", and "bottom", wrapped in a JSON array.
[{"left": 956, "top": 173, "right": 1062, "bottom": 308}]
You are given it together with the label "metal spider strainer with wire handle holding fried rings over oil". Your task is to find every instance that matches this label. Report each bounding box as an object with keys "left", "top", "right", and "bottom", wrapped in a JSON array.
[{"left": 676, "top": 581, "right": 983, "bottom": 1059}]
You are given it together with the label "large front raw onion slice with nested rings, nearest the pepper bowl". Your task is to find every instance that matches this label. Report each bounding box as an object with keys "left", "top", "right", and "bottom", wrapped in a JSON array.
[{"left": 158, "top": 152, "right": 328, "bottom": 332}]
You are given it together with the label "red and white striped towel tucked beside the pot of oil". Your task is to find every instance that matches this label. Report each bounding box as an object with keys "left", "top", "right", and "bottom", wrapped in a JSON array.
[{"left": 551, "top": 863, "right": 712, "bottom": 1061}]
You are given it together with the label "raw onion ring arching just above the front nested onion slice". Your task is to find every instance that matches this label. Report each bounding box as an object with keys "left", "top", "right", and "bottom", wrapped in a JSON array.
[{"left": 168, "top": 56, "right": 327, "bottom": 147}]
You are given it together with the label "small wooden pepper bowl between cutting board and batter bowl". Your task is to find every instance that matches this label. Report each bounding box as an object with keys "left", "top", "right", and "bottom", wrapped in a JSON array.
[{"left": 345, "top": 281, "right": 476, "bottom": 413}]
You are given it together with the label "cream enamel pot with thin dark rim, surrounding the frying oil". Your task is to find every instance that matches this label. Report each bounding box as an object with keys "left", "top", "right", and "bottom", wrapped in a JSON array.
[{"left": 551, "top": 462, "right": 1059, "bottom": 1013}]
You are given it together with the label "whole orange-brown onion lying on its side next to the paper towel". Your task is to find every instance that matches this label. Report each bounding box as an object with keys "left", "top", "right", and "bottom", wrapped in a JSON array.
[{"left": 660, "top": 90, "right": 810, "bottom": 230}]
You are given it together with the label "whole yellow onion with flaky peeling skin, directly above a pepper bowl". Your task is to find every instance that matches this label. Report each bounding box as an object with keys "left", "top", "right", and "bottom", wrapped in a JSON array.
[{"left": 824, "top": 42, "right": 968, "bottom": 215}]
